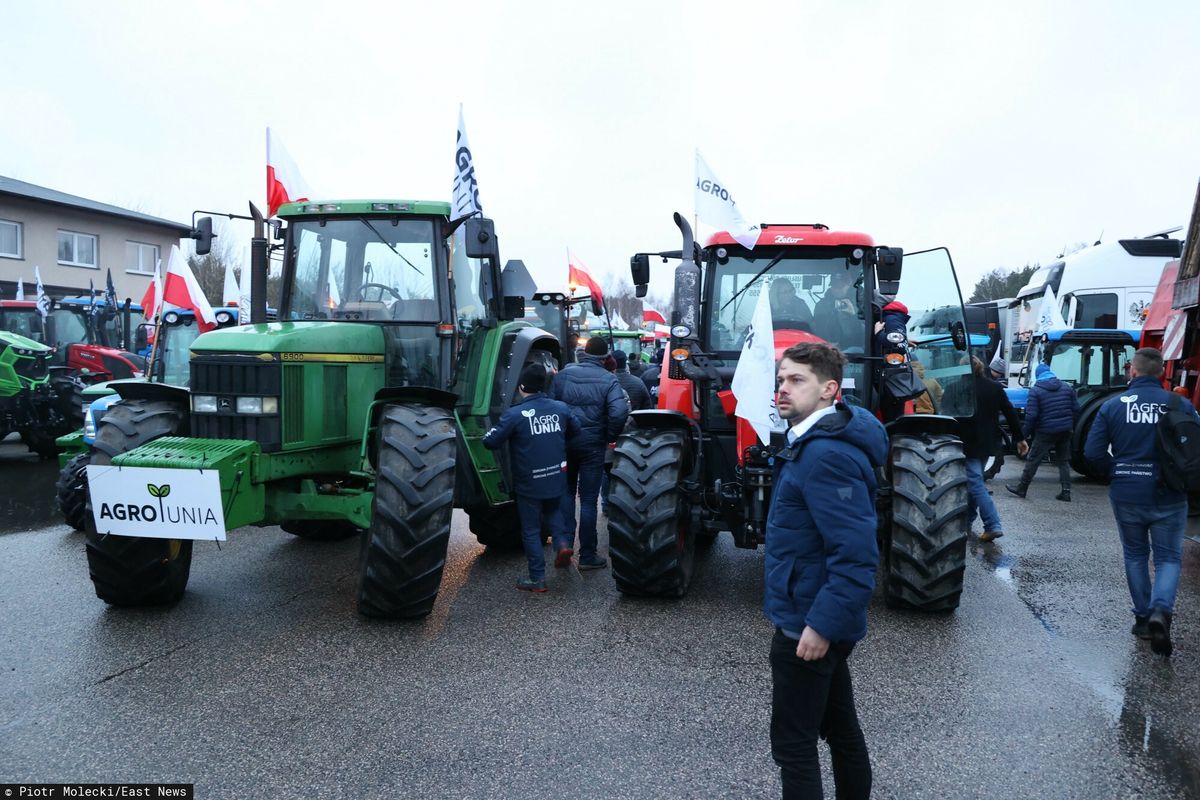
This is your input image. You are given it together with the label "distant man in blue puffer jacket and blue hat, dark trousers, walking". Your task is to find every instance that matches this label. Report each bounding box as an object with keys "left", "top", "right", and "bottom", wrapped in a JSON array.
[{"left": 1004, "top": 363, "right": 1079, "bottom": 503}]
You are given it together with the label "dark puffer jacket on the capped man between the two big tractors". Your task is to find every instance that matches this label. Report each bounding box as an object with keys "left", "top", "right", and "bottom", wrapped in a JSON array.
[{"left": 550, "top": 355, "right": 629, "bottom": 452}]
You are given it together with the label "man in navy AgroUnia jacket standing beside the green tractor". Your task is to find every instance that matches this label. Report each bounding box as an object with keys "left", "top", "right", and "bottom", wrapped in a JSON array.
[{"left": 484, "top": 363, "right": 580, "bottom": 593}]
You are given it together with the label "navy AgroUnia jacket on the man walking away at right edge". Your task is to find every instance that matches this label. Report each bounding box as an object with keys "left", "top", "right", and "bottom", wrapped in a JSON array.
[{"left": 1084, "top": 375, "right": 1195, "bottom": 506}]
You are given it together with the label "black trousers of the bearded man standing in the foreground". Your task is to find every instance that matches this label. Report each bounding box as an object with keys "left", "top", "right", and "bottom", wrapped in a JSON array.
[{"left": 770, "top": 631, "right": 871, "bottom": 800}]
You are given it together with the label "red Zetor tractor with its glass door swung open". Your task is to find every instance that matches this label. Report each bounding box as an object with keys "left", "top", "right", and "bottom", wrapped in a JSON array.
[{"left": 608, "top": 213, "right": 974, "bottom": 612}]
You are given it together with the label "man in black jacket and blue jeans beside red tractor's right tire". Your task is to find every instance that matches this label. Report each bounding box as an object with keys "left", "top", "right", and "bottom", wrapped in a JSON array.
[{"left": 947, "top": 359, "right": 1030, "bottom": 542}]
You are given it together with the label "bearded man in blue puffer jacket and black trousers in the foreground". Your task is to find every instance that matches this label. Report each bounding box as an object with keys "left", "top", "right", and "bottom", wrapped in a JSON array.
[{"left": 763, "top": 343, "right": 888, "bottom": 798}]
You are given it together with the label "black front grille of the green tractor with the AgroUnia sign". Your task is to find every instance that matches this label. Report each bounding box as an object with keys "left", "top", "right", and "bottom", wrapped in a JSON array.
[{"left": 191, "top": 356, "right": 283, "bottom": 452}]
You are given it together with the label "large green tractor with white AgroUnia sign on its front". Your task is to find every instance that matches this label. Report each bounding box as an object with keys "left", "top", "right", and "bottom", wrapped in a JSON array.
[{"left": 88, "top": 200, "right": 560, "bottom": 618}]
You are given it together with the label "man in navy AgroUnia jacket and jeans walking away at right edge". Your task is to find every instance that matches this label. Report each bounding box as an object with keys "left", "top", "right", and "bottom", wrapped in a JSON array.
[{"left": 1084, "top": 348, "right": 1195, "bottom": 656}]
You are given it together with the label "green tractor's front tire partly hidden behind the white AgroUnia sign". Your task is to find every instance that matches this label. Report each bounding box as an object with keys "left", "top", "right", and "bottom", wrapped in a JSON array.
[{"left": 84, "top": 399, "right": 192, "bottom": 606}]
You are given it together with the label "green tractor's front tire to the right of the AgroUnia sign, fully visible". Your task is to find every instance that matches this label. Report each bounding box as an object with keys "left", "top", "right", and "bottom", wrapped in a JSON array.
[{"left": 358, "top": 404, "right": 457, "bottom": 619}]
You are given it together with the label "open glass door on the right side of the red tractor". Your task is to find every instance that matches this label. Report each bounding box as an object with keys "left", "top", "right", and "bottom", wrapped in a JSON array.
[{"left": 895, "top": 248, "right": 974, "bottom": 417}]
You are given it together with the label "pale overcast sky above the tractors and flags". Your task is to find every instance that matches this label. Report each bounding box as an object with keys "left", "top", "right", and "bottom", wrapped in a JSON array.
[{"left": 0, "top": 0, "right": 1200, "bottom": 304}]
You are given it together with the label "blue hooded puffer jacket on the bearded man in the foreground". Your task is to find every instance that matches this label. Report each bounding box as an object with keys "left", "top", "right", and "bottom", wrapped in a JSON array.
[{"left": 763, "top": 403, "right": 888, "bottom": 642}]
